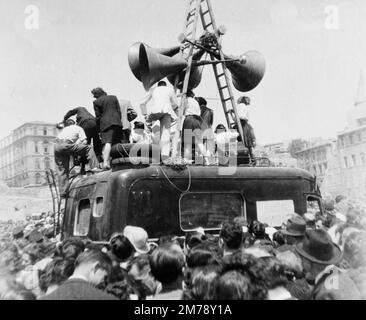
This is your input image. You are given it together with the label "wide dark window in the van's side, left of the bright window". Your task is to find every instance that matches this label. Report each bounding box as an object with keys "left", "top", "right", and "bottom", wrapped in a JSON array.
[{"left": 179, "top": 192, "right": 245, "bottom": 231}]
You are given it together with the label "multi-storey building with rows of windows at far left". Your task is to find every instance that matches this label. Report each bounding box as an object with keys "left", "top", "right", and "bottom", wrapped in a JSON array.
[{"left": 0, "top": 121, "right": 57, "bottom": 187}]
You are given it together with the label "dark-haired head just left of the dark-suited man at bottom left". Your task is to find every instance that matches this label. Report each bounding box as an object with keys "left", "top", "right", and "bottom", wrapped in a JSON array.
[{"left": 39, "top": 257, "right": 75, "bottom": 294}]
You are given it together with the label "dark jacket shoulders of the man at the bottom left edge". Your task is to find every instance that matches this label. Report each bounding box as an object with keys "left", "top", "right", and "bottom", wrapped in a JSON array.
[{"left": 40, "top": 279, "right": 118, "bottom": 300}]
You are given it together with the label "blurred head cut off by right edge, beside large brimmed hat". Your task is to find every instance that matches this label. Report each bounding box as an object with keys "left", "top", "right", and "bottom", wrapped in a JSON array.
[{"left": 340, "top": 231, "right": 366, "bottom": 269}]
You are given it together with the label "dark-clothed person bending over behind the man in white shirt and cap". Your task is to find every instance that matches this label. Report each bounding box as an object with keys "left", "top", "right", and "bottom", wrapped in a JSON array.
[{"left": 64, "top": 107, "right": 102, "bottom": 162}]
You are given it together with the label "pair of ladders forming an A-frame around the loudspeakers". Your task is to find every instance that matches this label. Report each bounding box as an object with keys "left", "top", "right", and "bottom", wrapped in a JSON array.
[{"left": 180, "top": 0, "right": 244, "bottom": 141}]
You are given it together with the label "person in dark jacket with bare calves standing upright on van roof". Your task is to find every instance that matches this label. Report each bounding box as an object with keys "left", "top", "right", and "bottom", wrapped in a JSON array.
[{"left": 91, "top": 88, "right": 124, "bottom": 169}]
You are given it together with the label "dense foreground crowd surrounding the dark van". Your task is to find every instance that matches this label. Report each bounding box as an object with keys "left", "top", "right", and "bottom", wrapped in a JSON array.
[{"left": 0, "top": 197, "right": 366, "bottom": 300}]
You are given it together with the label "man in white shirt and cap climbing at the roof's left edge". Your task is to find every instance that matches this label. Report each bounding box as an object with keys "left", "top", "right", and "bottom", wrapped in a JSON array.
[{"left": 55, "top": 119, "right": 98, "bottom": 198}]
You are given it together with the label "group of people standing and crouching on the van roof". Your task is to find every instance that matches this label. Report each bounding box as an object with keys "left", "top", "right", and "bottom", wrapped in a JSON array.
[{"left": 54, "top": 81, "right": 255, "bottom": 198}]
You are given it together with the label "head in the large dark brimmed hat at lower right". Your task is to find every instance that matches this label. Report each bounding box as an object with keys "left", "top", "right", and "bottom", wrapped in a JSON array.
[{"left": 296, "top": 229, "right": 341, "bottom": 280}]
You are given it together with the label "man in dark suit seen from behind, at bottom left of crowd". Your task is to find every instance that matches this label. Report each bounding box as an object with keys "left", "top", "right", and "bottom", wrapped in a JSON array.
[{"left": 40, "top": 250, "right": 117, "bottom": 300}]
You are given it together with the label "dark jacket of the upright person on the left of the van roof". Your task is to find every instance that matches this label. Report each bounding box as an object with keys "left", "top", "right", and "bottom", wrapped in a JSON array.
[{"left": 93, "top": 95, "right": 122, "bottom": 132}]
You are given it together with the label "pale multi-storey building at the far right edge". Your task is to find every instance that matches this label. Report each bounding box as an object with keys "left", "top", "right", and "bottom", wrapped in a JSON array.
[{"left": 298, "top": 72, "right": 366, "bottom": 200}]
